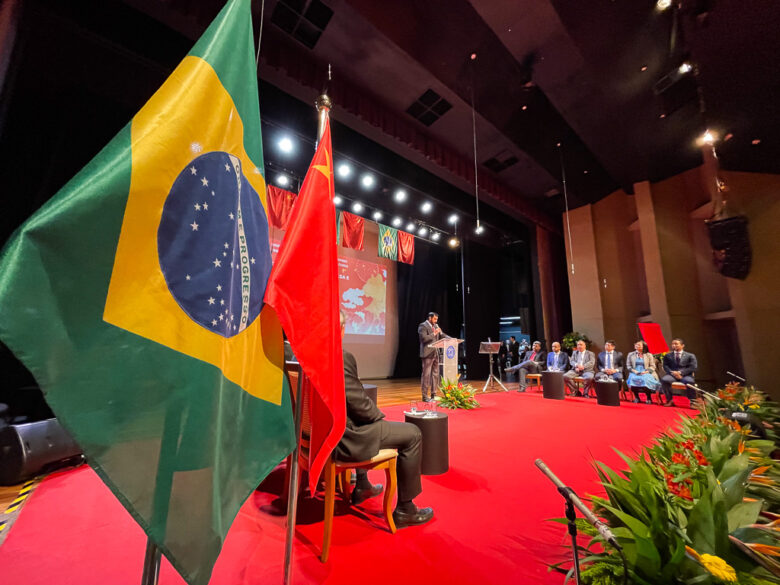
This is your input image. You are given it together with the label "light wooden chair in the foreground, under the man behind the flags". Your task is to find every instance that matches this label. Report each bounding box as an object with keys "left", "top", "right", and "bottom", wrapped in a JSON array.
[{"left": 283, "top": 364, "right": 398, "bottom": 563}]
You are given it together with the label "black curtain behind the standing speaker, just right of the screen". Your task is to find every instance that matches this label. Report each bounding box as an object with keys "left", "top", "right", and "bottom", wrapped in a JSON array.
[{"left": 393, "top": 239, "right": 462, "bottom": 378}]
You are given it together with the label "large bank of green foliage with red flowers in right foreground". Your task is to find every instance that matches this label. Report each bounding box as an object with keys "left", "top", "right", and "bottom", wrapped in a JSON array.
[{"left": 552, "top": 384, "right": 780, "bottom": 585}]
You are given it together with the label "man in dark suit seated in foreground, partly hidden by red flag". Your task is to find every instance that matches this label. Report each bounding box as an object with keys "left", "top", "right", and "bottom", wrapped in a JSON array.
[{"left": 334, "top": 313, "right": 433, "bottom": 528}]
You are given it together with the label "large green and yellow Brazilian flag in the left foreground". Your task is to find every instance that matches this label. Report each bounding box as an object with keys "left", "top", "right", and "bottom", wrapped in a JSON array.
[{"left": 0, "top": 0, "right": 294, "bottom": 585}]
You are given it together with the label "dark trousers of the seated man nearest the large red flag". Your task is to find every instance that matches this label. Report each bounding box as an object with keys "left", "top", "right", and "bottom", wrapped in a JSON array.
[{"left": 356, "top": 420, "right": 422, "bottom": 502}]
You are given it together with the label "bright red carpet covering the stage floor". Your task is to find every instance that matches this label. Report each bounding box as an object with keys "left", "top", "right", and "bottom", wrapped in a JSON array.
[{"left": 0, "top": 392, "right": 690, "bottom": 585}]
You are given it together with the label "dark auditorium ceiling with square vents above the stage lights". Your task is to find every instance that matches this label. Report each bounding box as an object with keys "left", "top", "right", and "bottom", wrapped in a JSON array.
[{"left": 6, "top": 0, "right": 780, "bottom": 239}]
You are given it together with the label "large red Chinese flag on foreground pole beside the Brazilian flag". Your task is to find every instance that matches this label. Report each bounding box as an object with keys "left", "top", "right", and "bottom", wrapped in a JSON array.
[{"left": 265, "top": 117, "right": 347, "bottom": 493}]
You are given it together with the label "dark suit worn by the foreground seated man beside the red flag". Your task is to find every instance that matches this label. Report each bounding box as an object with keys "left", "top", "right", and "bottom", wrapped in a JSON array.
[{"left": 334, "top": 351, "right": 422, "bottom": 502}]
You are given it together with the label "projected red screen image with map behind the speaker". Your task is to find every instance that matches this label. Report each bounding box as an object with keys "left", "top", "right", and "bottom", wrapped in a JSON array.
[{"left": 271, "top": 238, "right": 387, "bottom": 335}]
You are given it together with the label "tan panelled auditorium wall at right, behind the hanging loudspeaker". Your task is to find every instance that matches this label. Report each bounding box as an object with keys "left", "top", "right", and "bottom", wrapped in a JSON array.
[{"left": 564, "top": 168, "right": 780, "bottom": 397}]
